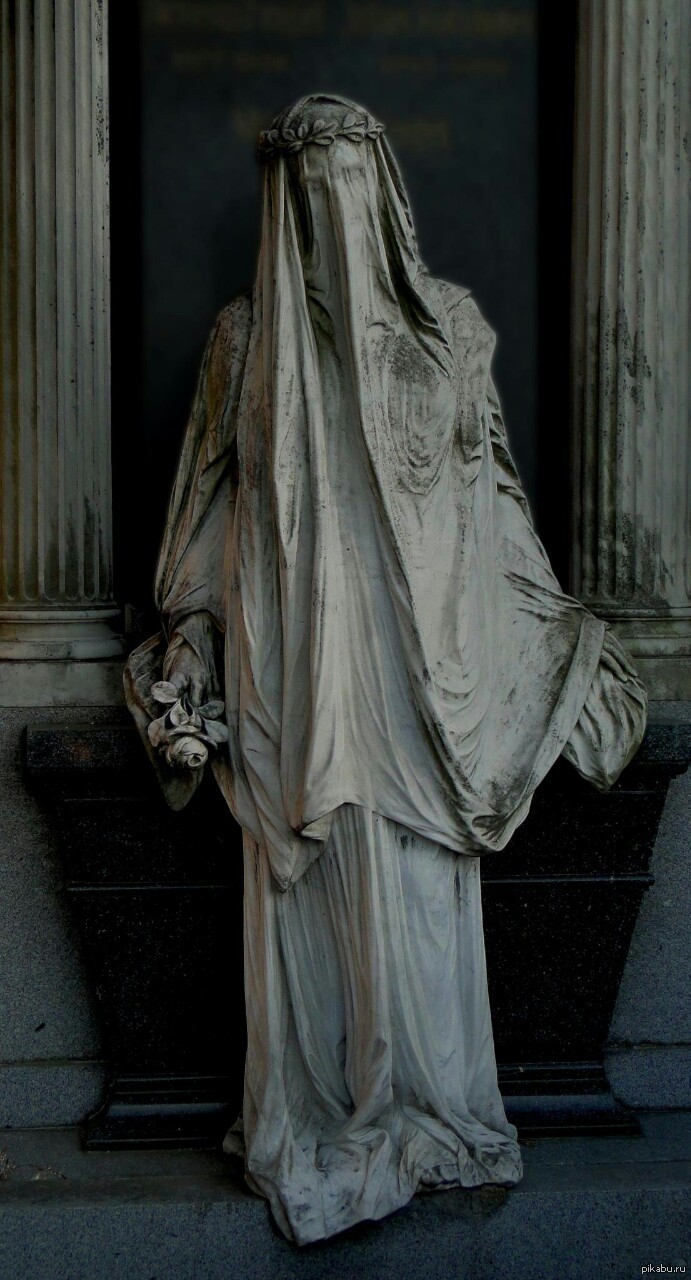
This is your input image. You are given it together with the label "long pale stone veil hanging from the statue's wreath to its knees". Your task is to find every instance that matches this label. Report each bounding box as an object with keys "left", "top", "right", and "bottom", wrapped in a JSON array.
[{"left": 140, "top": 94, "right": 644, "bottom": 888}]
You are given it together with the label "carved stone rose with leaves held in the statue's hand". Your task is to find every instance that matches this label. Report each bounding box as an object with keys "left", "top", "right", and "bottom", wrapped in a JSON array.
[{"left": 148, "top": 680, "right": 228, "bottom": 769}]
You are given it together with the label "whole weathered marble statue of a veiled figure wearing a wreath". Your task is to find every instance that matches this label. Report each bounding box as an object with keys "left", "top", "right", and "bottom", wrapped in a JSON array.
[{"left": 127, "top": 96, "right": 646, "bottom": 1244}]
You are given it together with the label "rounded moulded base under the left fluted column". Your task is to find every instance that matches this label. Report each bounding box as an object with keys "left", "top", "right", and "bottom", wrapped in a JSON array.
[{"left": 0, "top": 604, "right": 124, "bottom": 662}]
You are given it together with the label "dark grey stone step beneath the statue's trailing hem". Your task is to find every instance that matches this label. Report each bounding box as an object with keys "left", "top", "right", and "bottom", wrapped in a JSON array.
[{"left": 0, "top": 1112, "right": 691, "bottom": 1280}]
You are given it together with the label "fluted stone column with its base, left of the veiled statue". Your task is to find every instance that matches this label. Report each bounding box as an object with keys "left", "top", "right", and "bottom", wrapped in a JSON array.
[{"left": 0, "top": 0, "right": 122, "bottom": 684}]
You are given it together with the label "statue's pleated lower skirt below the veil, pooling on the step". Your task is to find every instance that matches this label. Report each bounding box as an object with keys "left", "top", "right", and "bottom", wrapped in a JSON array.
[{"left": 225, "top": 805, "right": 522, "bottom": 1244}]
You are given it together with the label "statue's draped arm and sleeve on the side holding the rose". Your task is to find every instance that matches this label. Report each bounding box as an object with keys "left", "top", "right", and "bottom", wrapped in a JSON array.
[{"left": 124, "top": 297, "right": 251, "bottom": 809}]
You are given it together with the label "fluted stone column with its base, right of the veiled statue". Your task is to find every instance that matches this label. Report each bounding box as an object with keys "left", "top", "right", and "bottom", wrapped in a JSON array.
[{"left": 572, "top": 0, "right": 691, "bottom": 698}]
